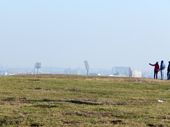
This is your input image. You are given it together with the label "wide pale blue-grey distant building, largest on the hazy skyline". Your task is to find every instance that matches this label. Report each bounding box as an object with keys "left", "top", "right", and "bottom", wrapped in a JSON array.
[{"left": 112, "top": 67, "right": 132, "bottom": 77}]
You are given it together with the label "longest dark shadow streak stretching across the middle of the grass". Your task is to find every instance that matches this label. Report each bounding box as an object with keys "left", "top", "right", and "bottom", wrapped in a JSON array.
[{"left": 22, "top": 99, "right": 103, "bottom": 105}]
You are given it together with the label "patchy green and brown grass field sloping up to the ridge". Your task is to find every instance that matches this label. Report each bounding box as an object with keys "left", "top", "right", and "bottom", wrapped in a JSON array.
[{"left": 0, "top": 75, "right": 170, "bottom": 127}]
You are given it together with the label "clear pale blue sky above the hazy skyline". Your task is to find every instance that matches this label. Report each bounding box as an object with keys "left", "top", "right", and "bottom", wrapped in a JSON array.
[{"left": 0, "top": 0, "right": 170, "bottom": 70}]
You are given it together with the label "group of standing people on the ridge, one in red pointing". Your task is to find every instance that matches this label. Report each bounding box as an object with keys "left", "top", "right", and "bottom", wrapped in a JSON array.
[{"left": 149, "top": 60, "right": 170, "bottom": 80}]
